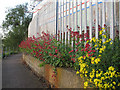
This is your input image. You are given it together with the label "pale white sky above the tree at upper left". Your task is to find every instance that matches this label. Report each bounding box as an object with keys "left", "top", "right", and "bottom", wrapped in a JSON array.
[{"left": 0, "top": 0, "right": 30, "bottom": 34}]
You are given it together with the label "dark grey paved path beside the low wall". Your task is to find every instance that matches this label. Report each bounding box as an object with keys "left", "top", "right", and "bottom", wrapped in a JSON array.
[{"left": 2, "top": 54, "right": 46, "bottom": 88}]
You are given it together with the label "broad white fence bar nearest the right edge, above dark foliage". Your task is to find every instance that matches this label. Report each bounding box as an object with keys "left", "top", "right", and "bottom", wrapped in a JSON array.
[{"left": 110, "top": 0, "right": 114, "bottom": 40}]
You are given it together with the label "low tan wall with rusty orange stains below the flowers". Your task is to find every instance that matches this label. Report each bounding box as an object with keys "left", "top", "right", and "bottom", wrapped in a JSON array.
[{"left": 23, "top": 54, "right": 84, "bottom": 88}]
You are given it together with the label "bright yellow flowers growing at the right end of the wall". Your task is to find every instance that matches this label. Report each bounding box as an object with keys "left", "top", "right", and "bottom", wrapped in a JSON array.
[{"left": 76, "top": 30, "right": 120, "bottom": 89}]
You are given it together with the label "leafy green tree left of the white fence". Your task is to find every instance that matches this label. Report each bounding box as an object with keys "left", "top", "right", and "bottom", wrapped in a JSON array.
[{"left": 2, "top": 4, "right": 32, "bottom": 48}]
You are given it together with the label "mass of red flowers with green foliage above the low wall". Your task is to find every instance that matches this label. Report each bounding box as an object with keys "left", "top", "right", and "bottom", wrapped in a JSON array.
[{"left": 19, "top": 26, "right": 106, "bottom": 65}]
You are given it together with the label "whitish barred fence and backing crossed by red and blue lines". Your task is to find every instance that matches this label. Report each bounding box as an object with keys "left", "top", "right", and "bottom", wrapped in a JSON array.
[{"left": 28, "top": 0, "right": 120, "bottom": 39}]
